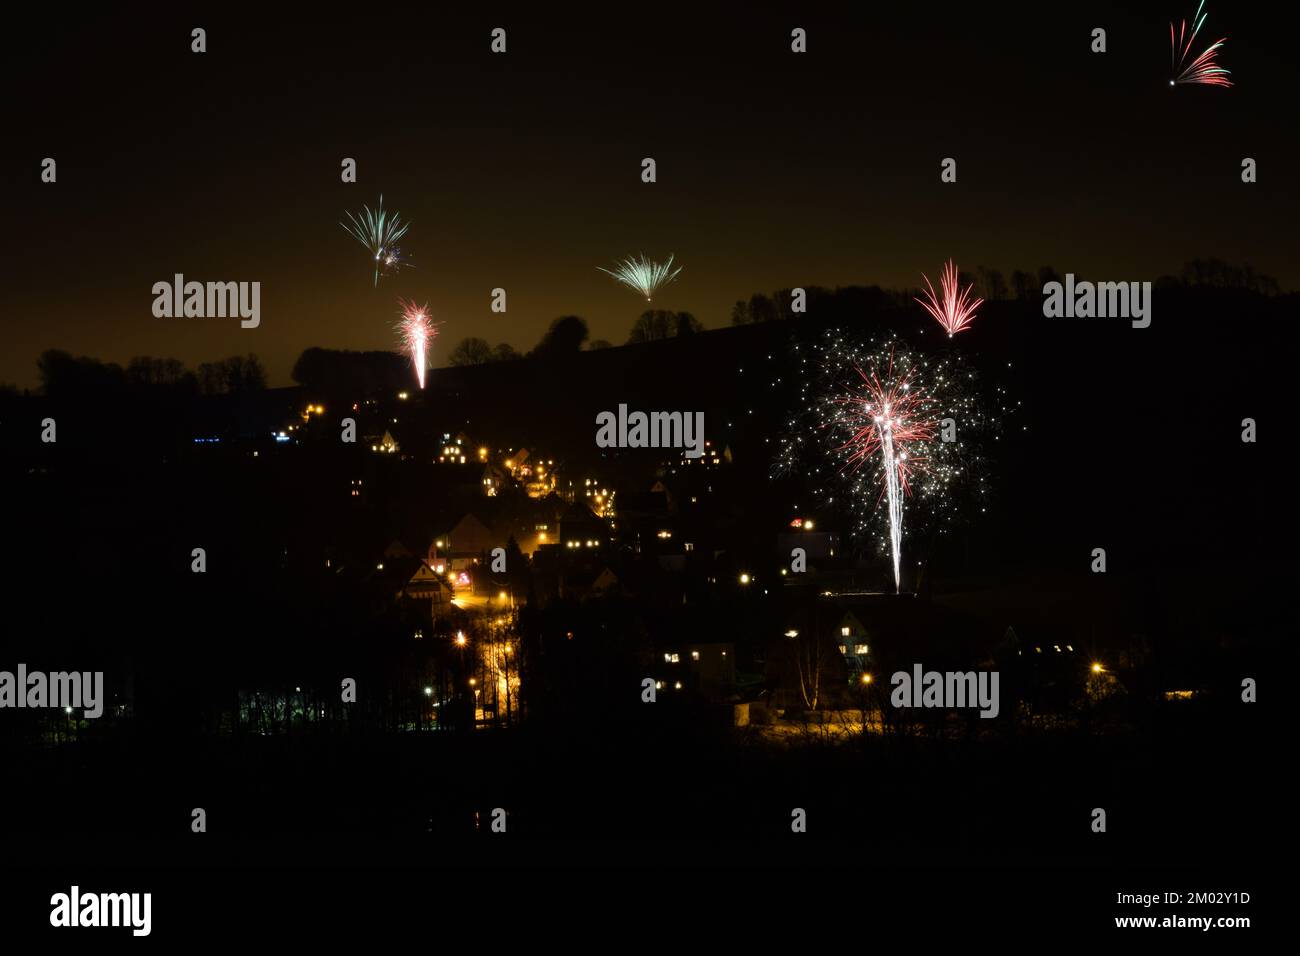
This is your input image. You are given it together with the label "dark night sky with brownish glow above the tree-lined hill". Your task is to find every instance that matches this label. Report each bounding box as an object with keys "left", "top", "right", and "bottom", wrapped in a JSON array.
[{"left": 0, "top": 0, "right": 1300, "bottom": 386}]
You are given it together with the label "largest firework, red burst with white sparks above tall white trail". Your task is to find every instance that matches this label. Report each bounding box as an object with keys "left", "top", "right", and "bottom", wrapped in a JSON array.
[{"left": 774, "top": 332, "right": 1008, "bottom": 591}]
